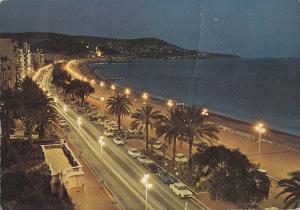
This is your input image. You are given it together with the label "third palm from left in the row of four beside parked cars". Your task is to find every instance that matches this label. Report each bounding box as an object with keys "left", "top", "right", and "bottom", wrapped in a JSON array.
[{"left": 157, "top": 108, "right": 183, "bottom": 161}]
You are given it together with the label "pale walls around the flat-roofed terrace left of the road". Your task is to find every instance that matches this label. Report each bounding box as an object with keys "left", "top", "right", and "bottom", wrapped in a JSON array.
[{"left": 41, "top": 143, "right": 84, "bottom": 199}]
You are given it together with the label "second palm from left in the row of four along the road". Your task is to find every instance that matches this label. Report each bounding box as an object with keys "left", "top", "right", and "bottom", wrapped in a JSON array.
[{"left": 131, "top": 105, "right": 162, "bottom": 149}]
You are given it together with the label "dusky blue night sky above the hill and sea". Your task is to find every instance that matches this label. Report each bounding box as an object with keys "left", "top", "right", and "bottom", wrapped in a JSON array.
[{"left": 0, "top": 0, "right": 300, "bottom": 57}]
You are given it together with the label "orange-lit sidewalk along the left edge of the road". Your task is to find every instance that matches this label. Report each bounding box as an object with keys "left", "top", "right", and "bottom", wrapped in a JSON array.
[{"left": 58, "top": 126, "right": 119, "bottom": 210}]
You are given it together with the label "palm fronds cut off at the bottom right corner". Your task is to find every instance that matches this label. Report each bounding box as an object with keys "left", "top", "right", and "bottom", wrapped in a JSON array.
[{"left": 276, "top": 171, "right": 300, "bottom": 209}]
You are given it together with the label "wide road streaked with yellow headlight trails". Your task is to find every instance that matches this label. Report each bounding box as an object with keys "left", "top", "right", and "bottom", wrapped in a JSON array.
[{"left": 38, "top": 67, "right": 206, "bottom": 210}]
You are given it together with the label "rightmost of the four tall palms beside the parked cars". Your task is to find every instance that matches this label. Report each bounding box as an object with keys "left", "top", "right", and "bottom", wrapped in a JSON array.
[{"left": 183, "top": 106, "right": 218, "bottom": 169}]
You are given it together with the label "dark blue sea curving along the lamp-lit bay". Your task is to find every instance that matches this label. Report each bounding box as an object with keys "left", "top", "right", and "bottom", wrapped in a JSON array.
[{"left": 92, "top": 58, "right": 300, "bottom": 136}]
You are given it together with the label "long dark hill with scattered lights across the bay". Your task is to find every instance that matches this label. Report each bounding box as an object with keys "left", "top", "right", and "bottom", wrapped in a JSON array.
[{"left": 0, "top": 32, "right": 236, "bottom": 58}]
